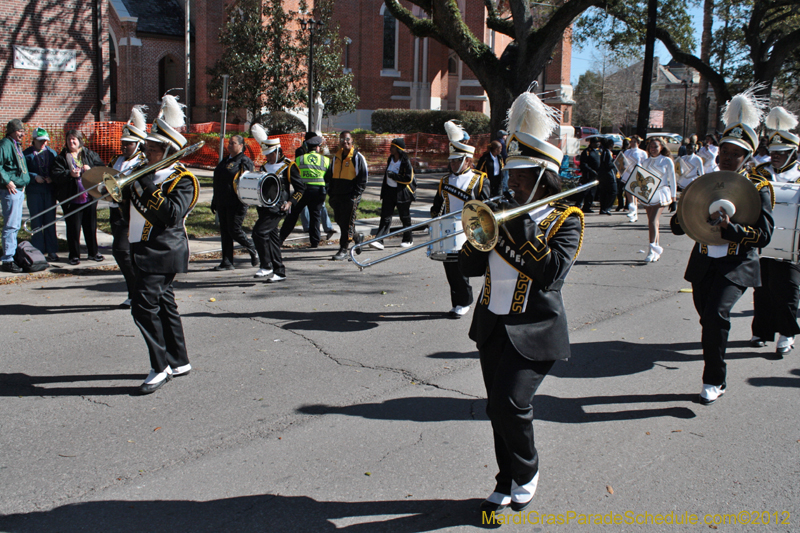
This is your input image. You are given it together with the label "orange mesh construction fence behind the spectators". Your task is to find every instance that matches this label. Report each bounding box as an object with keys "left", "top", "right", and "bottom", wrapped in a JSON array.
[{"left": 17, "top": 122, "right": 491, "bottom": 173}]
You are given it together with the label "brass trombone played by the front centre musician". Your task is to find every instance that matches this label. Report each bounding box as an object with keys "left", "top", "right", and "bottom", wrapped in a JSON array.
[{"left": 350, "top": 180, "right": 600, "bottom": 270}]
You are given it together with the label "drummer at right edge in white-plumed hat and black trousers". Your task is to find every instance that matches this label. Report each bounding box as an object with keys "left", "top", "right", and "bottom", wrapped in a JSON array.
[{"left": 750, "top": 107, "right": 800, "bottom": 358}]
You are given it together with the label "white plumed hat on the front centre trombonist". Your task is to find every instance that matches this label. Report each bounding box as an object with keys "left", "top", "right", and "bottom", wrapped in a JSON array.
[{"left": 503, "top": 83, "right": 564, "bottom": 174}]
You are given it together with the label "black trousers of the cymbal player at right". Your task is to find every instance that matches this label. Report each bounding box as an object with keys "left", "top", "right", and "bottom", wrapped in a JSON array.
[{"left": 692, "top": 266, "right": 746, "bottom": 386}]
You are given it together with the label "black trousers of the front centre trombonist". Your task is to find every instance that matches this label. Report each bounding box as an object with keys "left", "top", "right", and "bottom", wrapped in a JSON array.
[{"left": 479, "top": 317, "right": 555, "bottom": 495}]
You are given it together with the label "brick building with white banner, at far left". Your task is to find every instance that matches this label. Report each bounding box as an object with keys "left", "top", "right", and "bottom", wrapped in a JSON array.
[{"left": 0, "top": 0, "right": 110, "bottom": 124}]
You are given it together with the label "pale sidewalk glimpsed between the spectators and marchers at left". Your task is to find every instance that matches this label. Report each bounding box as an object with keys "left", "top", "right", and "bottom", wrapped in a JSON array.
[{"left": 0, "top": 168, "right": 441, "bottom": 279}]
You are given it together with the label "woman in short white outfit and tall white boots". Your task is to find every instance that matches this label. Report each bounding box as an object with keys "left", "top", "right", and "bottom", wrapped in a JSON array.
[{"left": 642, "top": 137, "right": 678, "bottom": 263}]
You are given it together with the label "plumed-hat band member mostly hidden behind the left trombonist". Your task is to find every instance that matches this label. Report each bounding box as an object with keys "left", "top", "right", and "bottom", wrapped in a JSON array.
[{"left": 108, "top": 106, "right": 147, "bottom": 309}]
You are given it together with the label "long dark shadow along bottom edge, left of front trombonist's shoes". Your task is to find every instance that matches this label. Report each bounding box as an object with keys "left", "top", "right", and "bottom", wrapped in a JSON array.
[{"left": 0, "top": 494, "right": 496, "bottom": 533}]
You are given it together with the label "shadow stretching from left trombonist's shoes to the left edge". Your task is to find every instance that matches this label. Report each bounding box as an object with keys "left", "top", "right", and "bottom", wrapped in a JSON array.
[{"left": 0, "top": 373, "right": 141, "bottom": 396}]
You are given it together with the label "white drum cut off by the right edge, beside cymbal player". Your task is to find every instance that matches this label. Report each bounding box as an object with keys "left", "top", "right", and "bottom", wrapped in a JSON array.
[{"left": 761, "top": 182, "right": 800, "bottom": 263}]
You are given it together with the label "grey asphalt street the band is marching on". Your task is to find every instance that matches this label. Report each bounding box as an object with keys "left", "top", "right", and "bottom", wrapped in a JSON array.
[{"left": 0, "top": 203, "right": 800, "bottom": 533}]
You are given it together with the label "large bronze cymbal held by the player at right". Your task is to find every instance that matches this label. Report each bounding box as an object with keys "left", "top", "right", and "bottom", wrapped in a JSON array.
[{"left": 678, "top": 170, "right": 761, "bottom": 245}]
